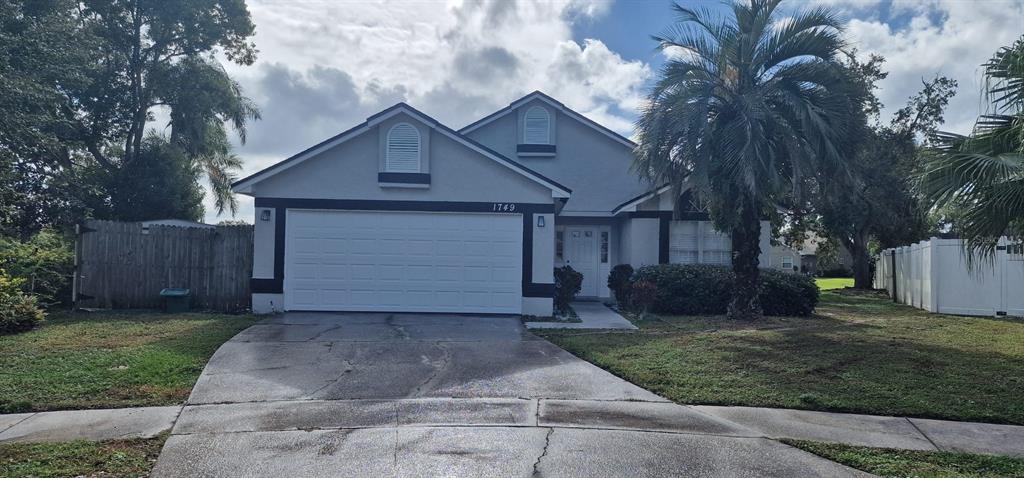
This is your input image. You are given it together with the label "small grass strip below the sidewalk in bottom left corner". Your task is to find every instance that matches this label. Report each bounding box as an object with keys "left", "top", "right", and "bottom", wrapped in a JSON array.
[{"left": 0, "top": 436, "right": 166, "bottom": 478}]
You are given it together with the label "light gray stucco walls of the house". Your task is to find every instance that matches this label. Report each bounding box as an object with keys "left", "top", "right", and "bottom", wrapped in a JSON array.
[{"left": 234, "top": 92, "right": 782, "bottom": 315}]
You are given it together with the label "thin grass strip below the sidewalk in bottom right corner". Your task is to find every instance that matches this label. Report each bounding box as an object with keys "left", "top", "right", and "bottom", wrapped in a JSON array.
[{"left": 783, "top": 440, "right": 1024, "bottom": 478}]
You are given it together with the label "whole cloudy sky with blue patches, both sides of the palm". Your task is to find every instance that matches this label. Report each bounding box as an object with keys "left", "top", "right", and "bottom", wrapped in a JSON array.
[{"left": 199, "top": 0, "right": 1024, "bottom": 222}]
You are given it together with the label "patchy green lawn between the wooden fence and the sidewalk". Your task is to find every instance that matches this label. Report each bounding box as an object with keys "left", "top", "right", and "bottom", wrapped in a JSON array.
[{"left": 0, "top": 312, "right": 256, "bottom": 412}]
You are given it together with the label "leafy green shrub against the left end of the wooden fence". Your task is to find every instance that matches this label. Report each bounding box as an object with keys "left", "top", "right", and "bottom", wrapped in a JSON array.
[{"left": 0, "top": 229, "right": 74, "bottom": 305}]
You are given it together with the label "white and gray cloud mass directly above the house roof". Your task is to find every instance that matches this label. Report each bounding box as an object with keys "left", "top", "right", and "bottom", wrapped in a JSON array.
[{"left": 207, "top": 0, "right": 650, "bottom": 221}]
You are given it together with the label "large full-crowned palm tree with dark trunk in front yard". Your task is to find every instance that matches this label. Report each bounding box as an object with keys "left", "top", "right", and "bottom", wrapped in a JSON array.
[{"left": 634, "top": 0, "right": 859, "bottom": 319}]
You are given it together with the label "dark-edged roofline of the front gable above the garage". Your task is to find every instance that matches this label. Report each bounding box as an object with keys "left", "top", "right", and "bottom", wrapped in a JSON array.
[{"left": 231, "top": 103, "right": 572, "bottom": 198}]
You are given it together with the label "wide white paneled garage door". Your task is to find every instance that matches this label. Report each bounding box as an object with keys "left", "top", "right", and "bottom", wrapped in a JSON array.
[{"left": 285, "top": 210, "right": 522, "bottom": 313}]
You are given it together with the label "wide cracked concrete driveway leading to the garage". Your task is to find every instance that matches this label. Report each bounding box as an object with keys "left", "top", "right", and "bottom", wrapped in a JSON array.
[{"left": 154, "top": 313, "right": 864, "bottom": 477}]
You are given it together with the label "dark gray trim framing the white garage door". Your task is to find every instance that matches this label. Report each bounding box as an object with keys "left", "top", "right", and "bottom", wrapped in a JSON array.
[{"left": 256, "top": 198, "right": 555, "bottom": 298}]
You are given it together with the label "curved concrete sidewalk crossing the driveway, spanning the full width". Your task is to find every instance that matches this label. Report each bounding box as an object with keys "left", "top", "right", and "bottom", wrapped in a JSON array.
[{"left": 0, "top": 398, "right": 1024, "bottom": 457}]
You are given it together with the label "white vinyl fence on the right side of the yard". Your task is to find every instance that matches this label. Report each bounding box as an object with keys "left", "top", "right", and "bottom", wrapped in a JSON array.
[{"left": 874, "top": 237, "right": 1024, "bottom": 316}]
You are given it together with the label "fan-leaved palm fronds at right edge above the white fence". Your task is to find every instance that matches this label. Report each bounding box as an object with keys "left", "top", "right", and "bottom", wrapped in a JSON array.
[{"left": 918, "top": 37, "right": 1024, "bottom": 260}]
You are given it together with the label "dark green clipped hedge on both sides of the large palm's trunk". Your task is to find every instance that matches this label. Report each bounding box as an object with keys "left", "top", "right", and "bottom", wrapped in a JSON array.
[{"left": 634, "top": 264, "right": 818, "bottom": 315}]
